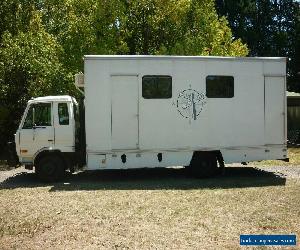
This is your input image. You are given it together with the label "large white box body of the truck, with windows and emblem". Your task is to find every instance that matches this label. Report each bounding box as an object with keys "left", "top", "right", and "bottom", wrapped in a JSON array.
[{"left": 84, "top": 56, "right": 287, "bottom": 169}]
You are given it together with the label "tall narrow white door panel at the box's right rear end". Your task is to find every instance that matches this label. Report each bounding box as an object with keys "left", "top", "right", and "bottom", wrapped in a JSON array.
[{"left": 265, "top": 77, "right": 285, "bottom": 144}]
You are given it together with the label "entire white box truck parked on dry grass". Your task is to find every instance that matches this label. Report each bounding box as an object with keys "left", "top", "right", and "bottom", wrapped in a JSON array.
[{"left": 15, "top": 55, "right": 288, "bottom": 181}]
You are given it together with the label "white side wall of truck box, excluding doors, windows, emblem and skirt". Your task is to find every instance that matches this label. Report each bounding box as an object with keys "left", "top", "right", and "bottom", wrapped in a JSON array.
[{"left": 85, "top": 56, "right": 285, "bottom": 167}]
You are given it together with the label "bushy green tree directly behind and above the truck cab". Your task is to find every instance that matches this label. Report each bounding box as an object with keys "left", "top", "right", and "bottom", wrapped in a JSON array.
[{"left": 0, "top": 13, "right": 75, "bottom": 148}]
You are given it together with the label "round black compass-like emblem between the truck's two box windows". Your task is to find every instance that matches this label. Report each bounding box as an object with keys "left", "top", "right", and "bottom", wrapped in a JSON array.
[{"left": 176, "top": 86, "right": 206, "bottom": 121}]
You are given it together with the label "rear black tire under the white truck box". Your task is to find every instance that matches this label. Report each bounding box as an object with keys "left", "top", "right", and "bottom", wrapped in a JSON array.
[{"left": 187, "top": 152, "right": 219, "bottom": 178}]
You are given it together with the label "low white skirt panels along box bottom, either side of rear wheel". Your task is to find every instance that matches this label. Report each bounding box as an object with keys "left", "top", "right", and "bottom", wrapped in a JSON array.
[{"left": 87, "top": 145, "right": 287, "bottom": 170}]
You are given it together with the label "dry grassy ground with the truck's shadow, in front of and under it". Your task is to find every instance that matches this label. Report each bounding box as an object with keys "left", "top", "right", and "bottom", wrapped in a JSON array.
[{"left": 0, "top": 167, "right": 300, "bottom": 249}]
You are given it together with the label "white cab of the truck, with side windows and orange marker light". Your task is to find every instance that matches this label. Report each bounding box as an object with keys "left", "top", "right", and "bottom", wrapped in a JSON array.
[{"left": 15, "top": 96, "right": 78, "bottom": 182}]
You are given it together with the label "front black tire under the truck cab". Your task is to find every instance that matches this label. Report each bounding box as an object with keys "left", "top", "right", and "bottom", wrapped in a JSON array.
[{"left": 35, "top": 154, "right": 65, "bottom": 182}]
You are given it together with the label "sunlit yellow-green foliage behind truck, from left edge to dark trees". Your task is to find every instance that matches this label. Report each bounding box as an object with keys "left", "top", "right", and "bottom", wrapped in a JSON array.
[{"left": 0, "top": 0, "right": 248, "bottom": 149}]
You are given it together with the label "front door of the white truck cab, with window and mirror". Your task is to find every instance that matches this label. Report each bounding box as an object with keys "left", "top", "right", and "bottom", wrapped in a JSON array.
[{"left": 19, "top": 102, "right": 54, "bottom": 161}]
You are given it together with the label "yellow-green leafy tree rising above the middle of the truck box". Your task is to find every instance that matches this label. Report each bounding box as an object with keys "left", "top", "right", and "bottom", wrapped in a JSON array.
[{"left": 120, "top": 0, "right": 248, "bottom": 56}]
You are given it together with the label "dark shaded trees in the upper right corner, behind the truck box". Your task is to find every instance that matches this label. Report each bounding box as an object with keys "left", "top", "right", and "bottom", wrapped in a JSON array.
[{"left": 216, "top": 0, "right": 300, "bottom": 92}]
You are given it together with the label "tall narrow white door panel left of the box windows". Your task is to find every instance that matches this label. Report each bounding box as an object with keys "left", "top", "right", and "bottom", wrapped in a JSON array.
[{"left": 110, "top": 75, "right": 139, "bottom": 149}]
